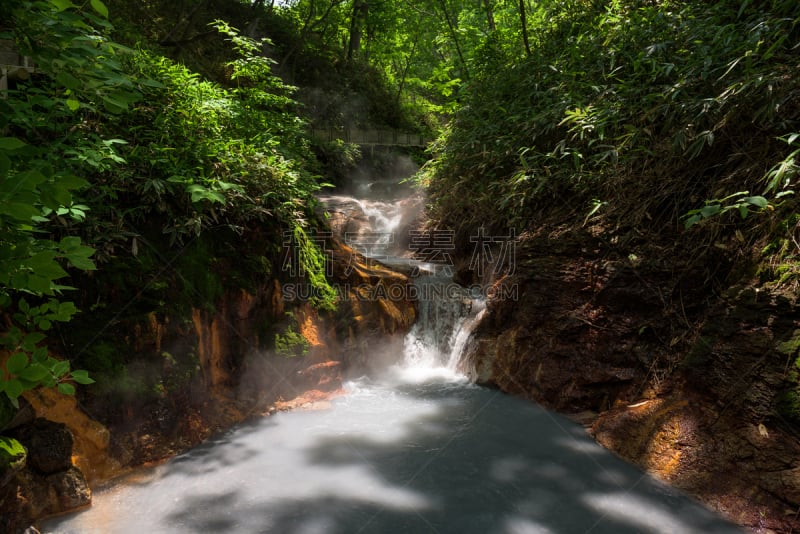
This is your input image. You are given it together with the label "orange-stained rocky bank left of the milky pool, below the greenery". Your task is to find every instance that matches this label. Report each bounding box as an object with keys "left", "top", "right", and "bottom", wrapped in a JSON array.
[{"left": 0, "top": 232, "right": 415, "bottom": 533}]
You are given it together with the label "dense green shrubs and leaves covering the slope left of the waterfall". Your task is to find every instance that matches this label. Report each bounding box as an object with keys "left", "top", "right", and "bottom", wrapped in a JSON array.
[{"left": 0, "top": 1, "right": 334, "bottom": 414}]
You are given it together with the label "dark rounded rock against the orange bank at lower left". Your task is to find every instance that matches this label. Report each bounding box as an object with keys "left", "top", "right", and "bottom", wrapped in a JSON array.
[{"left": 13, "top": 418, "right": 72, "bottom": 475}]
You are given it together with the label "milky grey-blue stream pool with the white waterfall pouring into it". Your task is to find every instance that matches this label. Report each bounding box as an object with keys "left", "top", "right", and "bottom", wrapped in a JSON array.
[{"left": 42, "top": 173, "right": 740, "bottom": 534}]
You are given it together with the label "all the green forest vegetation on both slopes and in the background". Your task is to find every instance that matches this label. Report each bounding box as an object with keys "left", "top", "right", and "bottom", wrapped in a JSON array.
[{"left": 0, "top": 0, "right": 800, "bottom": 528}]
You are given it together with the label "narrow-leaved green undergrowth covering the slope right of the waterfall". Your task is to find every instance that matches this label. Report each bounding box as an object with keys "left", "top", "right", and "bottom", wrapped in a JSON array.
[{"left": 421, "top": 0, "right": 800, "bottom": 234}]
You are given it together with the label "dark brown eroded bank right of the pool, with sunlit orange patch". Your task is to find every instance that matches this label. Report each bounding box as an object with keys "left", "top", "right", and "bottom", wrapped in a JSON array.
[{"left": 467, "top": 227, "right": 800, "bottom": 532}]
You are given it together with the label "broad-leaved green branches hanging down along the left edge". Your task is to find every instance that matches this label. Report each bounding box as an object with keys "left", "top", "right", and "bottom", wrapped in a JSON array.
[{"left": 0, "top": 0, "right": 139, "bottom": 406}]
